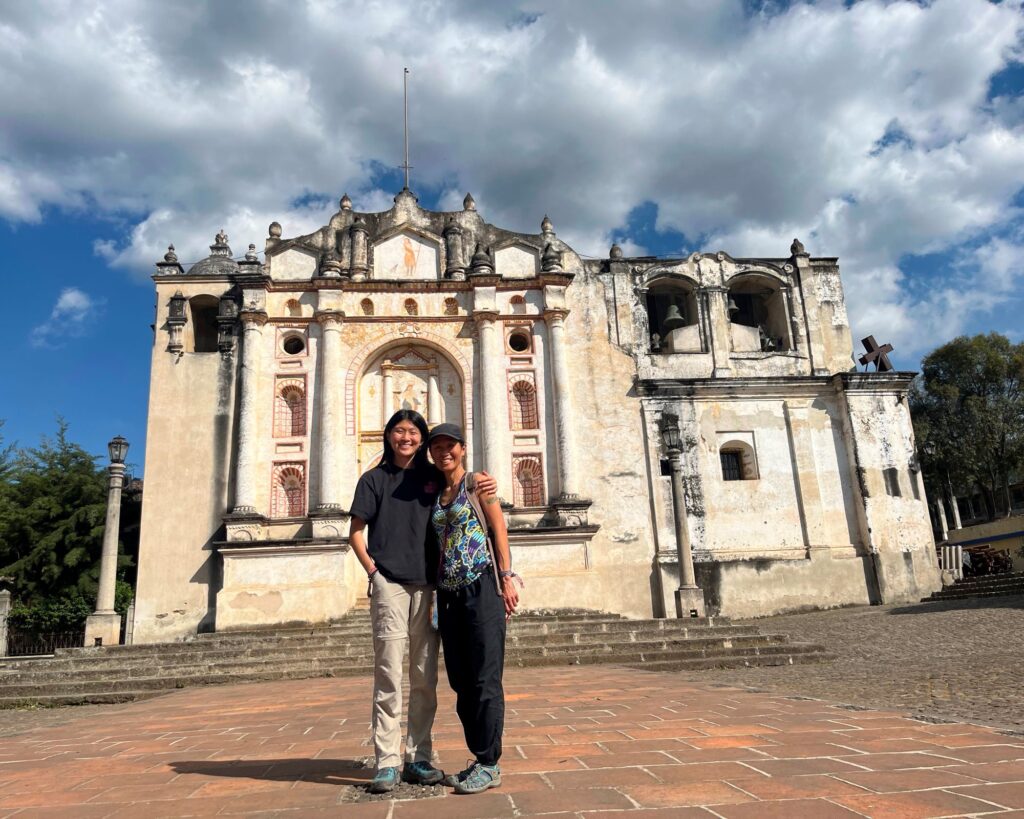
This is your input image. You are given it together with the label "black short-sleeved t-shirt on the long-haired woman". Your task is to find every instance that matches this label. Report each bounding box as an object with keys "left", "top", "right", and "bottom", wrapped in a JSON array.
[{"left": 349, "top": 464, "right": 444, "bottom": 586}]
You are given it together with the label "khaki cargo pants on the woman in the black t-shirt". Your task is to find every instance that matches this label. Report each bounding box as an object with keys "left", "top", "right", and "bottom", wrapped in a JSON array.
[{"left": 370, "top": 571, "right": 438, "bottom": 770}]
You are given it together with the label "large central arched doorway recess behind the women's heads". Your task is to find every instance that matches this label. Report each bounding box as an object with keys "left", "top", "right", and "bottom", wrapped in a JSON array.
[{"left": 357, "top": 343, "right": 465, "bottom": 474}]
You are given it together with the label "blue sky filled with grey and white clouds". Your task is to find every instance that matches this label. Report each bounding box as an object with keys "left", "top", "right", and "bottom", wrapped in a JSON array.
[{"left": 0, "top": 0, "right": 1024, "bottom": 474}]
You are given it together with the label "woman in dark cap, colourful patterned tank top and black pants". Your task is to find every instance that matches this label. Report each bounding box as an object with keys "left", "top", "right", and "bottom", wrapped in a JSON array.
[{"left": 428, "top": 424, "right": 519, "bottom": 793}]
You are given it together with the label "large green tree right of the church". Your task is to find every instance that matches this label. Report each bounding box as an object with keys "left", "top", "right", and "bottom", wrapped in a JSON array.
[{"left": 911, "top": 333, "right": 1024, "bottom": 518}]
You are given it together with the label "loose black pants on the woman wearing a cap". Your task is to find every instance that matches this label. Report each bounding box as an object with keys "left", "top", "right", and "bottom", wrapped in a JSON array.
[{"left": 437, "top": 568, "right": 505, "bottom": 765}]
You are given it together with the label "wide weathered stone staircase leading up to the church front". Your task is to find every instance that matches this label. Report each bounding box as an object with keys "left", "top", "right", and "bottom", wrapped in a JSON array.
[{"left": 0, "top": 609, "right": 830, "bottom": 707}]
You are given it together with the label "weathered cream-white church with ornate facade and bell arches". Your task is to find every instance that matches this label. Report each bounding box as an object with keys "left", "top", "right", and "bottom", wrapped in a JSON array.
[{"left": 133, "top": 189, "right": 940, "bottom": 642}]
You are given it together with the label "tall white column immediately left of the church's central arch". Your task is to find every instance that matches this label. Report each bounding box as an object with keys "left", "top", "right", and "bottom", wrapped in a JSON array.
[{"left": 315, "top": 310, "right": 344, "bottom": 514}]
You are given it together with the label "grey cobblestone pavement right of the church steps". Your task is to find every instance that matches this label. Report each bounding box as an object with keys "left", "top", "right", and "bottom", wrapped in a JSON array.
[{"left": 681, "top": 597, "right": 1024, "bottom": 731}]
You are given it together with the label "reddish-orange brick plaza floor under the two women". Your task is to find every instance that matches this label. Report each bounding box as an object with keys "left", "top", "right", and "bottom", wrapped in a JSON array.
[{"left": 0, "top": 666, "right": 1024, "bottom": 819}]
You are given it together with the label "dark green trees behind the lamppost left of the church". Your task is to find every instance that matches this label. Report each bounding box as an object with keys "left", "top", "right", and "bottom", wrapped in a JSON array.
[{"left": 0, "top": 420, "right": 139, "bottom": 621}]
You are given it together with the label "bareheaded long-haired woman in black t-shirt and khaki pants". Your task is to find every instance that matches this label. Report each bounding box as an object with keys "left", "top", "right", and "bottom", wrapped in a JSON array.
[{"left": 349, "top": 410, "right": 497, "bottom": 793}]
